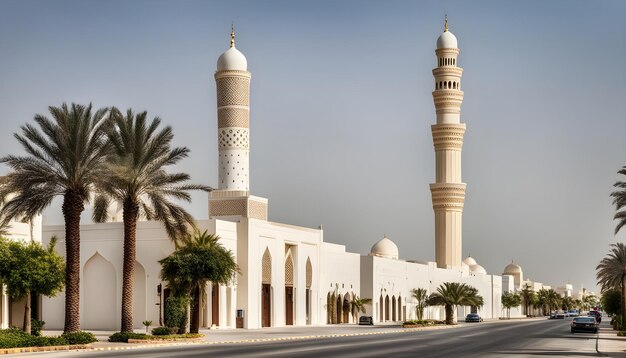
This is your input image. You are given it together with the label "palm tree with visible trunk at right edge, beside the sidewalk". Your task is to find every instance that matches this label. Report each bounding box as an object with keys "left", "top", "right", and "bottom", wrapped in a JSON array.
[{"left": 596, "top": 242, "right": 626, "bottom": 328}]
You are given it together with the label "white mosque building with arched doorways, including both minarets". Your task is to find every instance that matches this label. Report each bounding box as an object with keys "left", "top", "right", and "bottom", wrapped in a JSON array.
[{"left": 0, "top": 20, "right": 560, "bottom": 330}]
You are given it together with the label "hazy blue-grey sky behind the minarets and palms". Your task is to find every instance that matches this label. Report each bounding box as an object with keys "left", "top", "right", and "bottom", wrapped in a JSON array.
[{"left": 0, "top": 0, "right": 626, "bottom": 291}]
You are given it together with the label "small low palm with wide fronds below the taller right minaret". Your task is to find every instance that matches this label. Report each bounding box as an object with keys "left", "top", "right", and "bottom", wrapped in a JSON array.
[{"left": 428, "top": 282, "right": 484, "bottom": 324}]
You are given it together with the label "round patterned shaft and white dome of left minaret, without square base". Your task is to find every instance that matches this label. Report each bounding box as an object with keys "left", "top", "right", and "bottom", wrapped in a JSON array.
[{"left": 215, "top": 26, "right": 251, "bottom": 192}]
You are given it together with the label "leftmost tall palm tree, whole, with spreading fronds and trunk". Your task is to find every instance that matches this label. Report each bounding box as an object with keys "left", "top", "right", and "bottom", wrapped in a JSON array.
[{"left": 0, "top": 103, "right": 108, "bottom": 333}]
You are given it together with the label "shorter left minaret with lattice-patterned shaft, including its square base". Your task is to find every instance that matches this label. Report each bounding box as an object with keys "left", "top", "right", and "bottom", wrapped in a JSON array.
[{"left": 209, "top": 25, "right": 267, "bottom": 221}]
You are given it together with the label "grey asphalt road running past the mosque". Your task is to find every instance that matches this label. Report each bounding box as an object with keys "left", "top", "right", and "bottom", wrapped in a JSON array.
[{"left": 30, "top": 320, "right": 598, "bottom": 358}]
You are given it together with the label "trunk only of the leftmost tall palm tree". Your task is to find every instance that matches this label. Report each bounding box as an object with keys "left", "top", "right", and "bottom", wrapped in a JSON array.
[{"left": 63, "top": 191, "right": 85, "bottom": 333}]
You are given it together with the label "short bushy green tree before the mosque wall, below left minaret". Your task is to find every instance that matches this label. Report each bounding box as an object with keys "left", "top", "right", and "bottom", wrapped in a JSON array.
[{"left": 159, "top": 230, "right": 239, "bottom": 333}]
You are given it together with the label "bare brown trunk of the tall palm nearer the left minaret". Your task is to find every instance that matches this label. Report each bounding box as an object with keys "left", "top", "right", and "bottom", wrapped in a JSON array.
[{"left": 122, "top": 200, "right": 139, "bottom": 332}]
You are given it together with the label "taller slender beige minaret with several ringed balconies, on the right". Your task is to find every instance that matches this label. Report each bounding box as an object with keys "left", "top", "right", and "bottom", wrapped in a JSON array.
[{"left": 430, "top": 16, "right": 466, "bottom": 268}]
